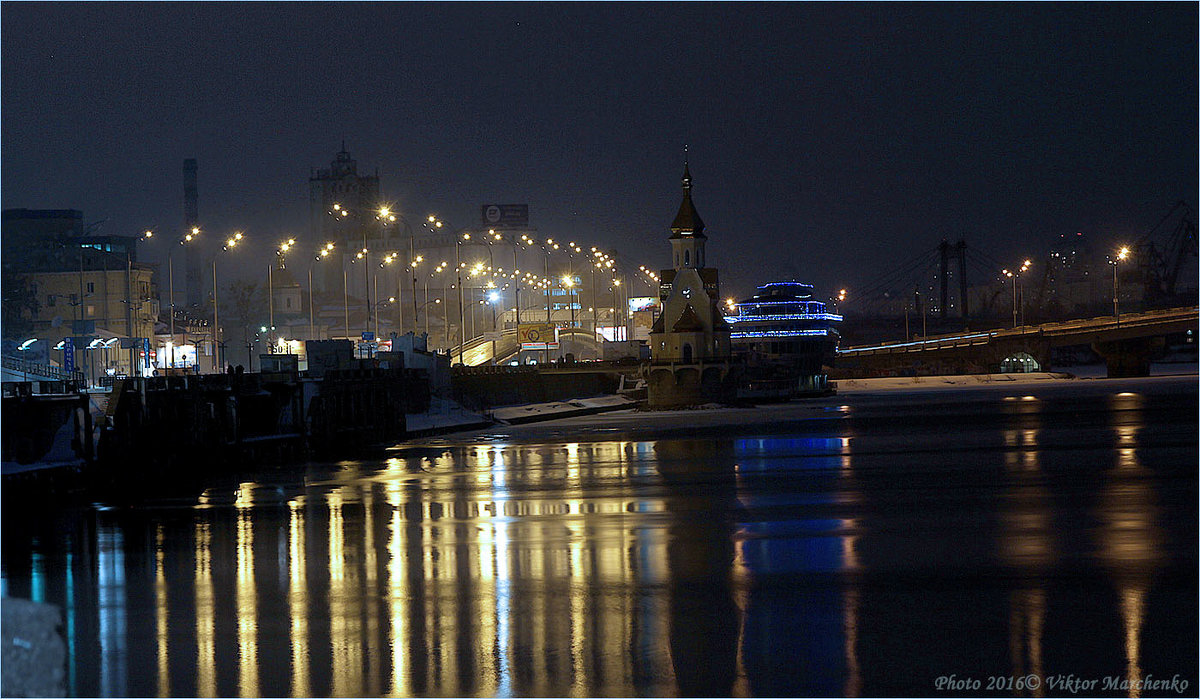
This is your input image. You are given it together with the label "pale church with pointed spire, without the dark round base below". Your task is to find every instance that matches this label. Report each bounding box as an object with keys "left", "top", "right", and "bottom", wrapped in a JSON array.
[{"left": 650, "top": 162, "right": 730, "bottom": 371}]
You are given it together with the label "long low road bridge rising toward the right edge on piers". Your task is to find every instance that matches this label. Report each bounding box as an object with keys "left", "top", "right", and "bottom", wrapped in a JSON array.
[{"left": 838, "top": 306, "right": 1200, "bottom": 377}]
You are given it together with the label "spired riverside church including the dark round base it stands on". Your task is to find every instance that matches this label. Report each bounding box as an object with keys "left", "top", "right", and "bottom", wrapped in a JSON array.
[{"left": 643, "top": 163, "right": 734, "bottom": 407}]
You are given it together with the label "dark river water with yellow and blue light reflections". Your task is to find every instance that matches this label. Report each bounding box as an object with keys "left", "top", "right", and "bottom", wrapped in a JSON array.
[{"left": 0, "top": 376, "right": 1198, "bottom": 697}]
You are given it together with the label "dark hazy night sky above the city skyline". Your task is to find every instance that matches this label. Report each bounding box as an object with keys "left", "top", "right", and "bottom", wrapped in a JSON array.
[{"left": 0, "top": 2, "right": 1200, "bottom": 295}]
